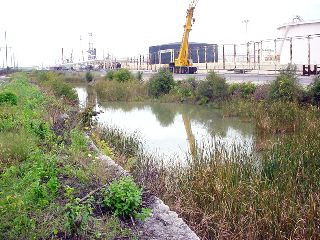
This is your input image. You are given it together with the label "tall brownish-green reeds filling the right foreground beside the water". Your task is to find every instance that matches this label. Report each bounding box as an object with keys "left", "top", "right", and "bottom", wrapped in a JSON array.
[{"left": 97, "top": 102, "right": 320, "bottom": 239}]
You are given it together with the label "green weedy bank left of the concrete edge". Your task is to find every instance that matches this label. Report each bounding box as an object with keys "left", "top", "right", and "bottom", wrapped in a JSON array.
[{"left": 0, "top": 72, "right": 148, "bottom": 239}]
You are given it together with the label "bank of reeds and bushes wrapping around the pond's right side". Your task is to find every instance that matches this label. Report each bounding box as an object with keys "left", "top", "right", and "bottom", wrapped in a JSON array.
[{"left": 86, "top": 68, "right": 320, "bottom": 239}]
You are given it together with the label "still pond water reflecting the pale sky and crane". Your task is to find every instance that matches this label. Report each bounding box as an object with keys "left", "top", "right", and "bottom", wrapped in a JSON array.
[{"left": 75, "top": 84, "right": 254, "bottom": 159}]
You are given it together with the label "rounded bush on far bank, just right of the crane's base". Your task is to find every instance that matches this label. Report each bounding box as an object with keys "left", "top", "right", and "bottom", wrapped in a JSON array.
[{"left": 197, "top": 72, "right": 228, "bottom": 100}]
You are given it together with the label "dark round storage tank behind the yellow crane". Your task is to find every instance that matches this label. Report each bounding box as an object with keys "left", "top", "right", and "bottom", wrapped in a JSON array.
[{"left": 149, "top": 43, "right": 218, "bottom": 64}]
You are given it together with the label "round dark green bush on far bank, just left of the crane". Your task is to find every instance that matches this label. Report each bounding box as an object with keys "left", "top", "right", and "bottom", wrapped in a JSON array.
[{"left": 148, "top": 69, "right": 175, "bottom": 97}]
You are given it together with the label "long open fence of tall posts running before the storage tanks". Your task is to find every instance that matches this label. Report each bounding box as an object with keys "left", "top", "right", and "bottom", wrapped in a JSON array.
[{"left": 117, "top": 34, "right": 320, "bottom": 71}]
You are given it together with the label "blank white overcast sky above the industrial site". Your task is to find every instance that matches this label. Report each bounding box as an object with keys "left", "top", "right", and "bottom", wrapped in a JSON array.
[{"left": 0, "top": 0, "right": 320, "bottom": 66}]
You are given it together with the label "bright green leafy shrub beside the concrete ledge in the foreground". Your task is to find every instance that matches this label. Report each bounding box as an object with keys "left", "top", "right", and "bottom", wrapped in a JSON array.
[{"left": 103, "top": 177, "right": 142, "bottom": 216}]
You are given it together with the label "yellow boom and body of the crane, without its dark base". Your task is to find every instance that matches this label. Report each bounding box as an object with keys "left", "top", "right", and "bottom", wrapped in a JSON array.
[{"left": 174, "top": 0, "right": 199, "bottom": 67}]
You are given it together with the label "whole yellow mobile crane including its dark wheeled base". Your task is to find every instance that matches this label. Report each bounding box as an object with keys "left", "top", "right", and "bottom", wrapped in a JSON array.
[{"left": 169, "top": 0, "right": 199, "bottom": 74}]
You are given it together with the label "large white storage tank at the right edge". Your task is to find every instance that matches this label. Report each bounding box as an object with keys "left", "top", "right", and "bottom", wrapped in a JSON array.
[{"left": 278, "top": 20, "right": 320, "bottom": 66}]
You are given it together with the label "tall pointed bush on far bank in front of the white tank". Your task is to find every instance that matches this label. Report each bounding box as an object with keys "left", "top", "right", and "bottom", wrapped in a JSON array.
[{"left": 269, "top": 65, "right": 300, "bottom": 101}]
